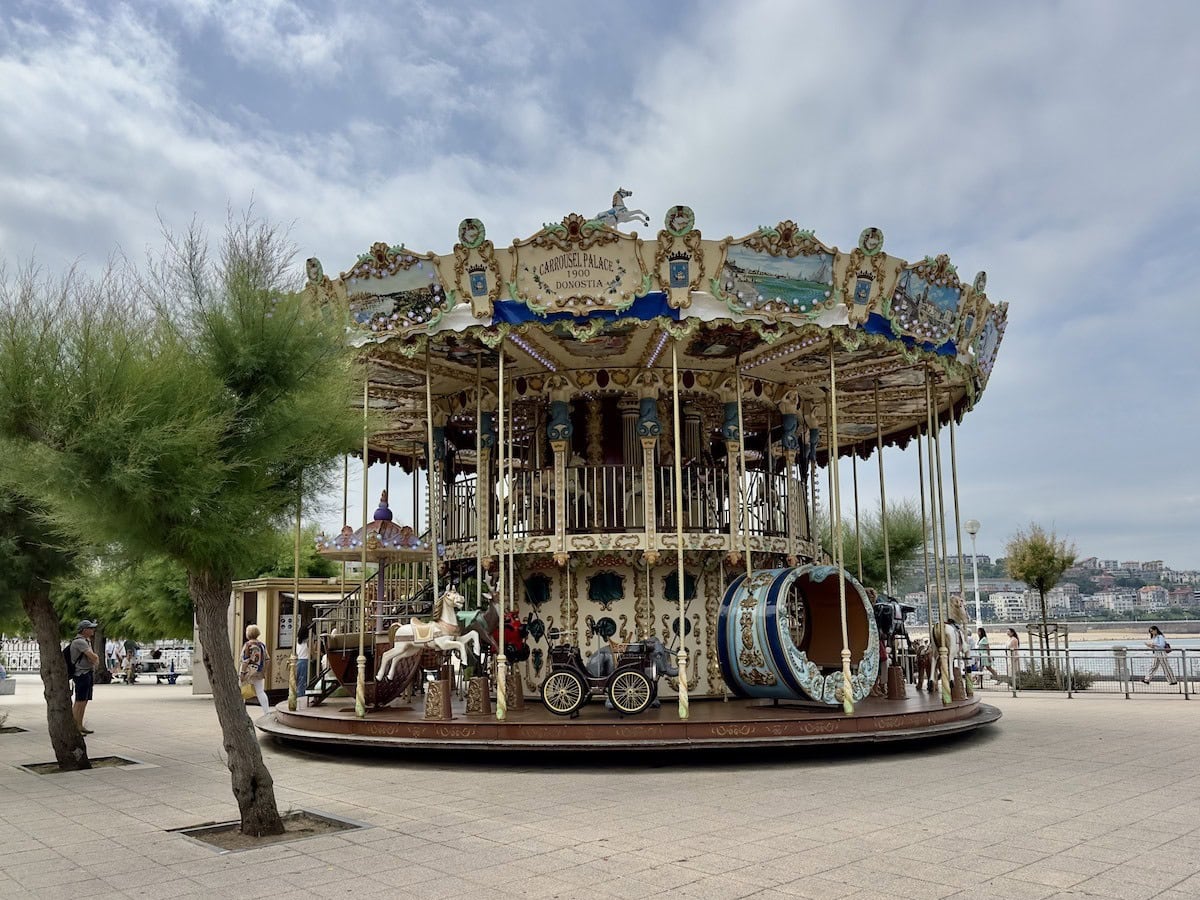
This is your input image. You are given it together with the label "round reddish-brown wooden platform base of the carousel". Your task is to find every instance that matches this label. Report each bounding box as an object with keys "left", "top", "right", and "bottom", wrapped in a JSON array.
[{"left": 257, "top": 690, "right": 1001, "bottom": 751}]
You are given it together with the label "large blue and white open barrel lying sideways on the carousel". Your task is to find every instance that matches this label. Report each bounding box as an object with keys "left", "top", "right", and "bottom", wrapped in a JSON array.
[{"left": 716, "top": 565, "right": 880, "bottom": 706}]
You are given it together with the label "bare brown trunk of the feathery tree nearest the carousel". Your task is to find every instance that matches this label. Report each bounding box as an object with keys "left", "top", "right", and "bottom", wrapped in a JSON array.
[{"left": 187, "top": 572, "right": 283, "bottom": 838}]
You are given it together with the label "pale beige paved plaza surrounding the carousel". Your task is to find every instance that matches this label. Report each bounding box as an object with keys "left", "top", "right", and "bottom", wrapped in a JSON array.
[{"left": 0, "top": 676, "right": 1200, "bottom": 900}]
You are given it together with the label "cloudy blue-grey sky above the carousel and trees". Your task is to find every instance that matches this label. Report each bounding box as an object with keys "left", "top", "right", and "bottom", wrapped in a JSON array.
[{"left": 0, "top": 0, "right": 1200, "bottom": 569}]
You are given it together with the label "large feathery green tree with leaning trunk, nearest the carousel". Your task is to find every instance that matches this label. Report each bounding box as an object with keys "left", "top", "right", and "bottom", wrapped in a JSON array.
[{"left": 0, "top": 215, "right": 362, "bottom": 835}]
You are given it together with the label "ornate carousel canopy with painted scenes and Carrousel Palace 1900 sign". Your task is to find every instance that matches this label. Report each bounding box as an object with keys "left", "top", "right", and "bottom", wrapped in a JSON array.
[{"left": 306, "top": 202, "right": 1008, "bottom": 464}]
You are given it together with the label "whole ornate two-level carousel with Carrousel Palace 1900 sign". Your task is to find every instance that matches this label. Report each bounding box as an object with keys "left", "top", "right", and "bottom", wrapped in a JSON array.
[{"left": 259, "top": 190, "right": 1007, "bottom": 749}]
